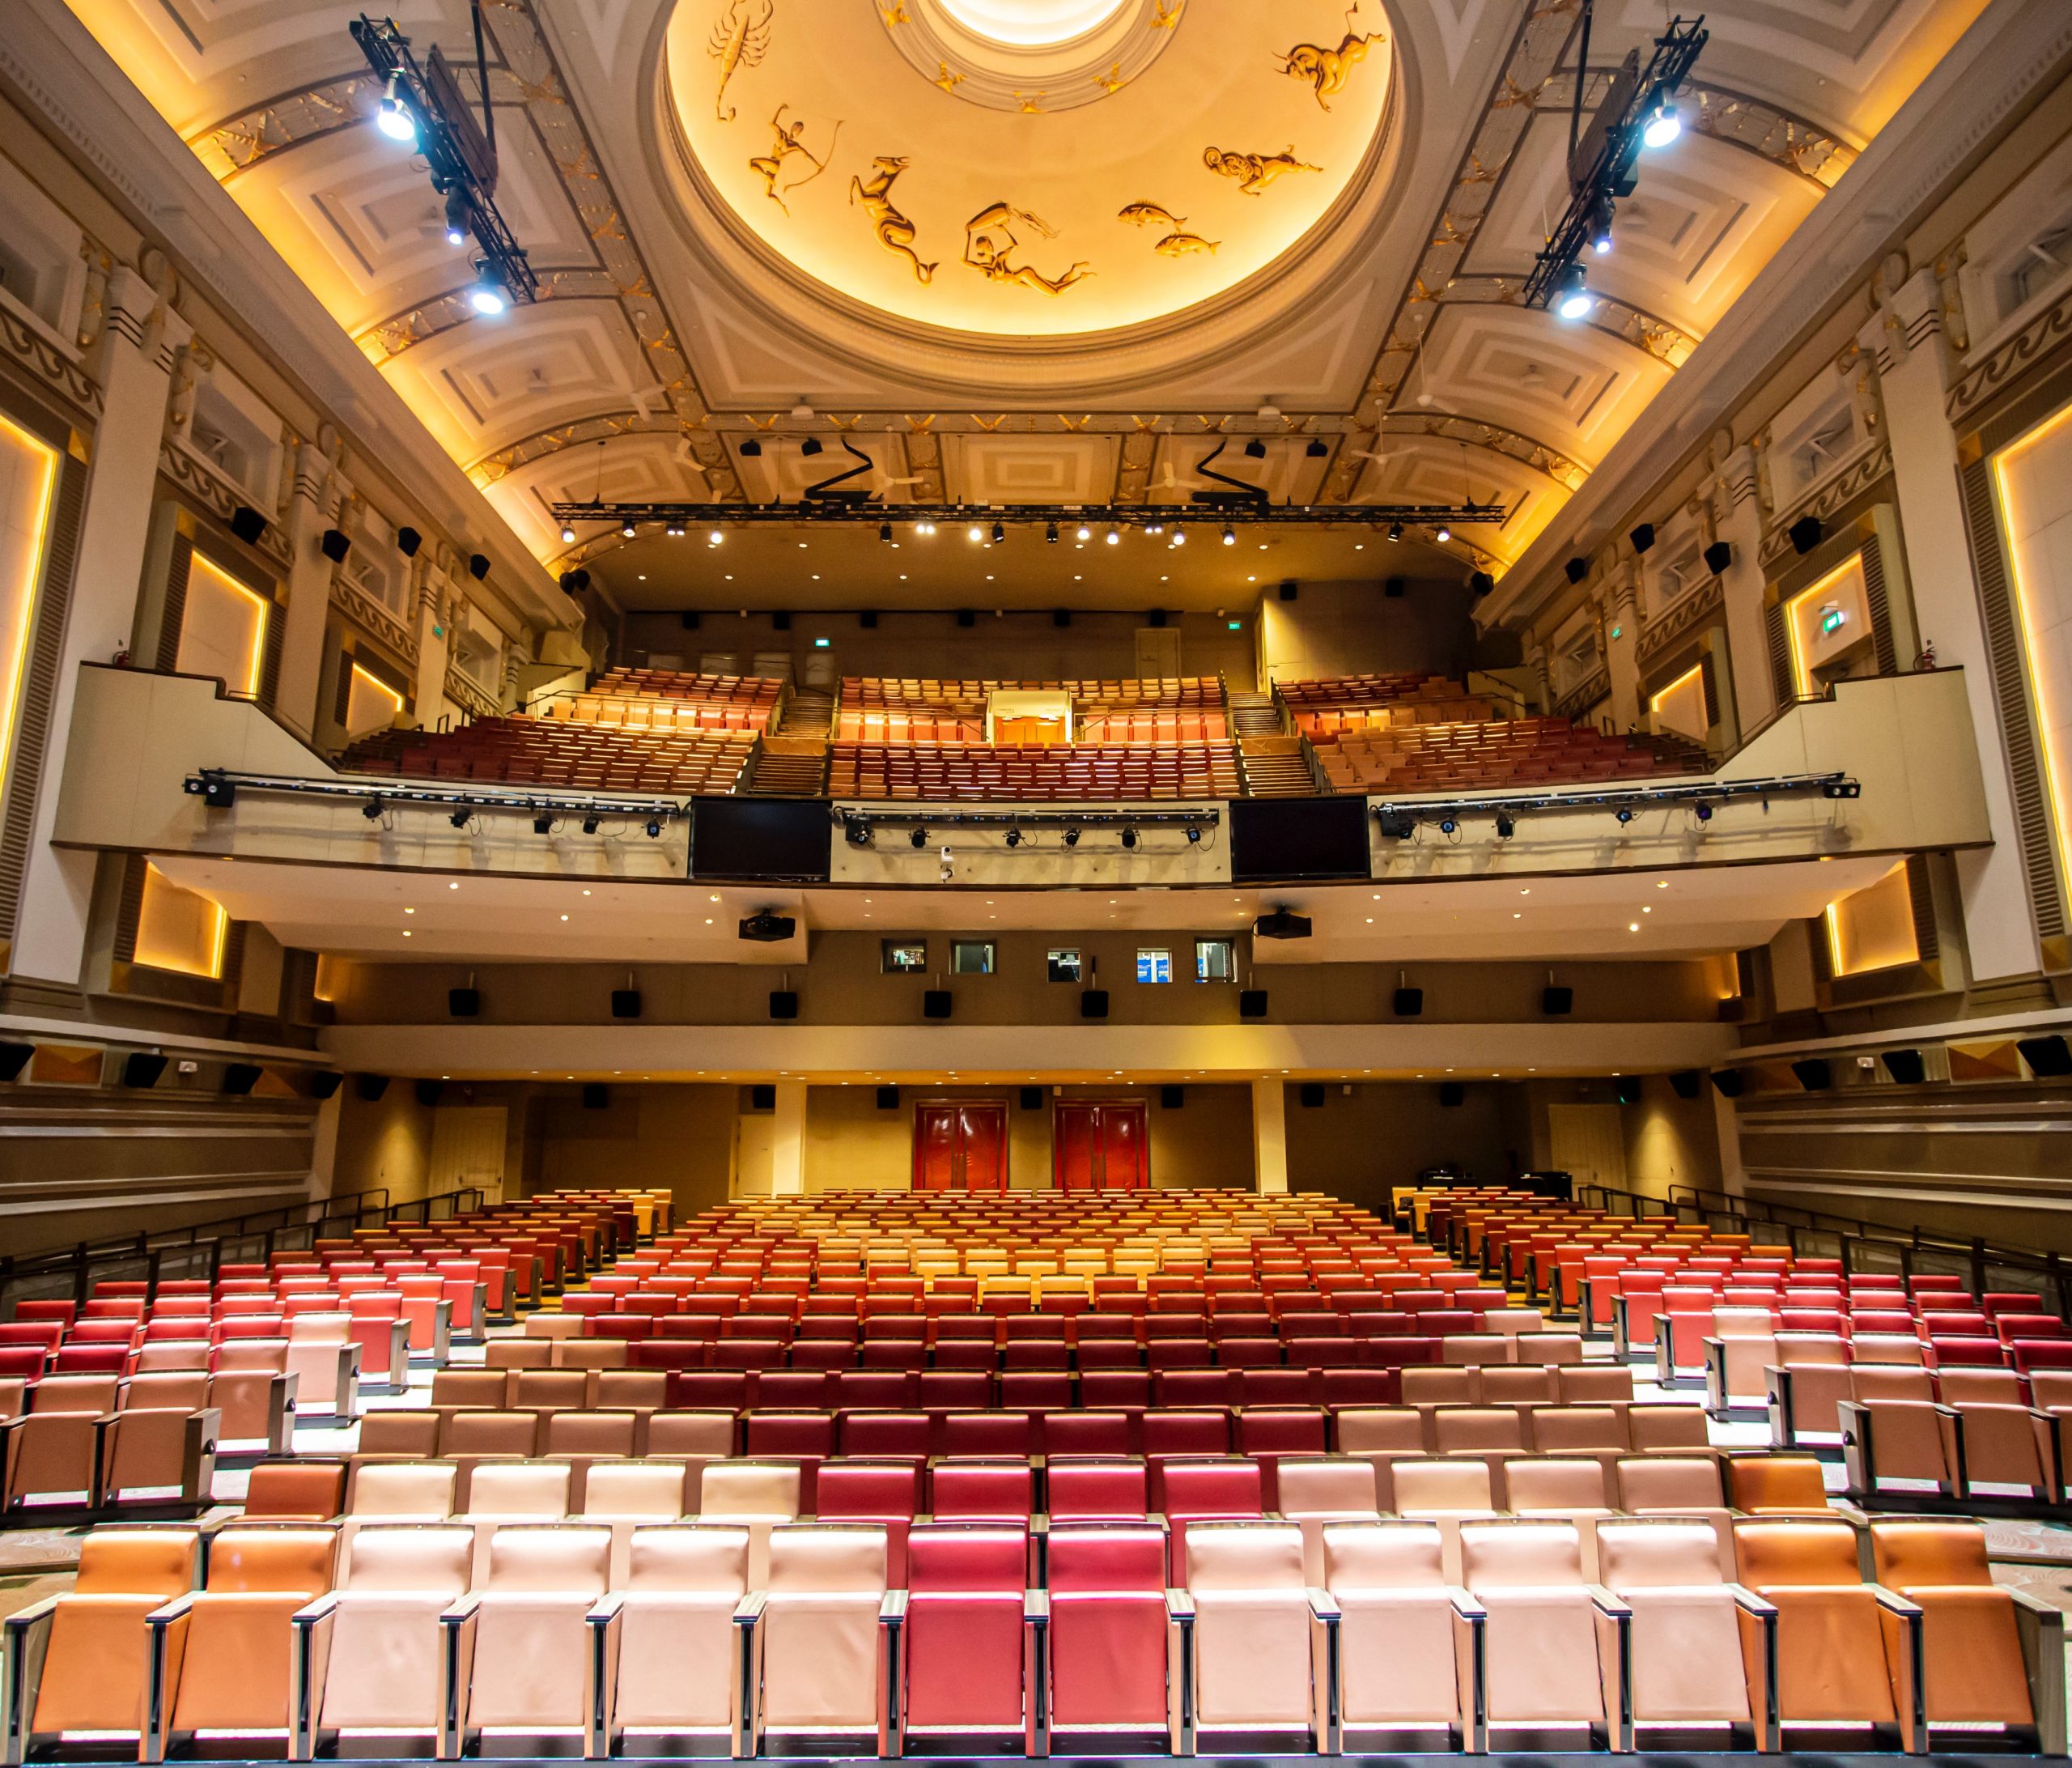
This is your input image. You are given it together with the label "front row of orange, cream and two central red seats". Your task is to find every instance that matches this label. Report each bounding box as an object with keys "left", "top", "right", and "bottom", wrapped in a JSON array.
[{"left": 6, "top": 1515, "right": 2064, "bottom": 1762}]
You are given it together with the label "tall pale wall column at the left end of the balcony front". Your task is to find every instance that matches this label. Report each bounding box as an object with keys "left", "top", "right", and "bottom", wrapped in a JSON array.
[{"left": 11, "top": 251, "right": 191, "bottom": 987}]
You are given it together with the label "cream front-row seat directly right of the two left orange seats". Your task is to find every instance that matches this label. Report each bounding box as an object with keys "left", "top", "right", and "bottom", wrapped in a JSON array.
[{"left": 295, "top": 1524, "right": 474, "bottom": 1760}]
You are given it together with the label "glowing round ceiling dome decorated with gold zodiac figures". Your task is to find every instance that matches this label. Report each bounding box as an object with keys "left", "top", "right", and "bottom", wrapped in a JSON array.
[{"left": 665, "top": 0, "right": 1392, "bottom": 338}]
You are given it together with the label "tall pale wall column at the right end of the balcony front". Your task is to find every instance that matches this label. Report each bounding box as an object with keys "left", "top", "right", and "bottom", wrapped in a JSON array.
[{"left": 1861, "top": 270, "right": 2043, "bottom": 983}]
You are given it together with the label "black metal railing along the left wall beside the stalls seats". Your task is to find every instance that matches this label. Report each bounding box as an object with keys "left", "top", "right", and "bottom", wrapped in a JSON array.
[{"left": 0, "top": 1186, "right": 485, "bottom": 1312}]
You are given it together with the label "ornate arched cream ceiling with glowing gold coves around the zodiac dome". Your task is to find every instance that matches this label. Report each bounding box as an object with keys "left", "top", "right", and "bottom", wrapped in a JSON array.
[{"left": 66, "top": 0, "right": 1985, "bottom": 607}]
